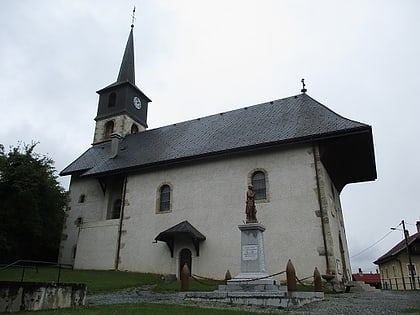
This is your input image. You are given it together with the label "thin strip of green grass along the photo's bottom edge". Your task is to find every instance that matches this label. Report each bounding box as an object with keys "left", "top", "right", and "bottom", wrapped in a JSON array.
[{"left": 15, "top": 303, "right": 286, "bottom": 315}]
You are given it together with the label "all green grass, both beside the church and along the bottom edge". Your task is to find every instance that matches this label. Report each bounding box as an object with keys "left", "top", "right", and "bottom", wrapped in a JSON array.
[{"left": 0, "top": 267, "right": 286, "bottom": 315}]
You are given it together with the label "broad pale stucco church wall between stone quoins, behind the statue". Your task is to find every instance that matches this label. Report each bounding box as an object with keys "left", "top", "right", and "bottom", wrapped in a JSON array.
[{"left": 120, "top": 147, "right": 325, "bottom": 278}]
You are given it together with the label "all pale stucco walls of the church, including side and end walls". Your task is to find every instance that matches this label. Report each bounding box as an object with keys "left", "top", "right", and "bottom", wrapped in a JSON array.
[{"left": 61, "top": 146, "right": 351, "bottom": 280}]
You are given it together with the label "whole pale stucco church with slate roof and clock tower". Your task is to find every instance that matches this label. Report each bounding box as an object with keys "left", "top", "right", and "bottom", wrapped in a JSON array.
[{"left": 59, "top": 21, "right": 377, "bottom": 282}]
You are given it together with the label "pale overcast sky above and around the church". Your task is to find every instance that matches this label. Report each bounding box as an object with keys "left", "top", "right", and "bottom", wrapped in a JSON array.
[{"left": 0, "top": 0, "right": 420, "bottom": 271}]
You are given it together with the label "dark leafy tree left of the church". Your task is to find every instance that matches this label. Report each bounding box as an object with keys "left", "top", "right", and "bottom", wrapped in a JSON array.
[{"left": 0, "top": 143, "right": 67, "bottom": 263}]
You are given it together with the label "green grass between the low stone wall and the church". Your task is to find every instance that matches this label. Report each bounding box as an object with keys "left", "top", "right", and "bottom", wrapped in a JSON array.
[{"left": 0, "top": 267, "right": 221, "bottom": 294}]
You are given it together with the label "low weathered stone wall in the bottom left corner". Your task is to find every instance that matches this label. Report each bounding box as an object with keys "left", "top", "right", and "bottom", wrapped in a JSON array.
[{"left": 0, "top": 281, "right": 87, "bottom": 312}]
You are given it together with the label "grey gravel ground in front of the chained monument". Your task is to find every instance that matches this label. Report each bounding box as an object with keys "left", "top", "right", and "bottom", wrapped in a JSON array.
[{"left": 87, "top": 287, "right": 420, "bottom": 315}]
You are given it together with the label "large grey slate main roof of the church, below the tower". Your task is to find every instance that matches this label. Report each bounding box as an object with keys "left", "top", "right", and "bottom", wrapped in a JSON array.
[{"left": 60, "top": 94, "right": 376, "bottom": 190}]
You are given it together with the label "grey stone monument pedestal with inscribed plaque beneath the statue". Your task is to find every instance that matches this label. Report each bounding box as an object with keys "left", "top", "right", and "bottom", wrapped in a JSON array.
[{"left": 227, "top": 223, "right": 275, "bottom": 291}]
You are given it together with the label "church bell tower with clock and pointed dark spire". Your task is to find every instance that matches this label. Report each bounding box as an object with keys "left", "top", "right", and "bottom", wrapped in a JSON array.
[{"left": 93, "top": 24, "right": 151, "bottom": 144}]
